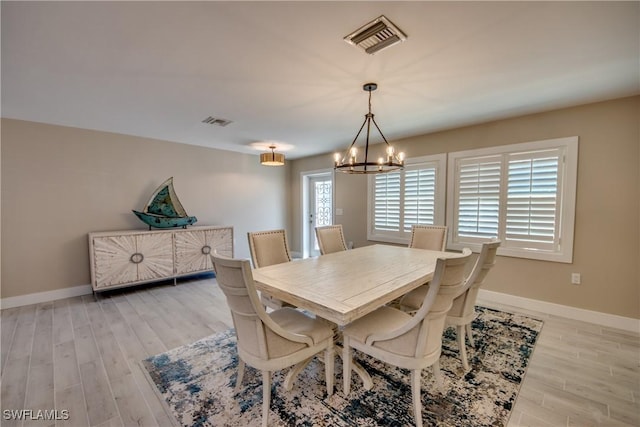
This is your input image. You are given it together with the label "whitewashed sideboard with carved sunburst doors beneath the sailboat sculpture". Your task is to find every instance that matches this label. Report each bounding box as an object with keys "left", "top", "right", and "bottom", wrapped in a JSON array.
[{"left": 89, "top": 226, "right": 233, "bottom": 292}]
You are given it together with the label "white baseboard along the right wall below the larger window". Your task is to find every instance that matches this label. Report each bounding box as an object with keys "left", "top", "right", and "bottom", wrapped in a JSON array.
[{"left": 478, "top": 289, "right": 640, "bottom": 334}]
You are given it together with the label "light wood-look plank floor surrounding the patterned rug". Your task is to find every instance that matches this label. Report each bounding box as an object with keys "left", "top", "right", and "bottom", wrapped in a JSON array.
[{"left": 0, "top": 278, "right": 640, "bottom": 427}]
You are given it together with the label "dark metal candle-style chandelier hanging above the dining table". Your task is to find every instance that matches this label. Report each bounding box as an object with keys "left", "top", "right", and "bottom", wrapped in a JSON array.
[{"left": 334, "top": 83, "right": 404, "bottom": 174}]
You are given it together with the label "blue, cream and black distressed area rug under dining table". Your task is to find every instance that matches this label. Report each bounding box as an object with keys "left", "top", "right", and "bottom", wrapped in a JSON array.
[{"left": 142, "top": 307, "right": 542, "bottom": 427}]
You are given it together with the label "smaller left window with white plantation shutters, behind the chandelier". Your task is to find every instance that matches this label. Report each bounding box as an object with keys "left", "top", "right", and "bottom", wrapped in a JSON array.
[{"left": 368, "top": 154, "right": 446, "bottom": 243}]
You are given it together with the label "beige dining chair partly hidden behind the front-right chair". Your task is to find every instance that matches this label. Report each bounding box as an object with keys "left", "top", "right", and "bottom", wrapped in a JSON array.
[{"left": 400, "top": 240, "right": 501, "bottom": 371}]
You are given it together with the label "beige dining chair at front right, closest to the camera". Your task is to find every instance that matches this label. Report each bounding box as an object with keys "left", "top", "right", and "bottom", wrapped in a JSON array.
[{"left": 342, "top": 249, "right": 471, "bottom": 427}]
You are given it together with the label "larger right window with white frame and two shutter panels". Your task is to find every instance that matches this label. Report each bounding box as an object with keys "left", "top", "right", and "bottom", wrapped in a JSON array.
[{"left": 447, "top": 137, "right": 578, "bottom": 262}]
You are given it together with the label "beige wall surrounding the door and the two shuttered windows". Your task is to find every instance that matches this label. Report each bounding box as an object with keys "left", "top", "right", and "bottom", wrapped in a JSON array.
[{"left": 289, "top": 96, "right": 640, "bottom": 318}]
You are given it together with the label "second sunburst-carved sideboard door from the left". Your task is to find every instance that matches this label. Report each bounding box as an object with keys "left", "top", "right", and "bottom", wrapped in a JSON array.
[{"left": 134, "top": 233, "right": 173, "bottom": 281}]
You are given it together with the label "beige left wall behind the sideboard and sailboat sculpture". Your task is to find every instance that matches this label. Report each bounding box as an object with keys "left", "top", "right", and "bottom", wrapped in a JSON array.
[{"left": 0, "top": 119, "right": 288, "bottom": 298}]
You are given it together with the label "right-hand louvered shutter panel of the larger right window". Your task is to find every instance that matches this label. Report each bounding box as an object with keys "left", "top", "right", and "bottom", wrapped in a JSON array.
[{"left": 505, "top": 150, "right": 562, "bottom": 250}]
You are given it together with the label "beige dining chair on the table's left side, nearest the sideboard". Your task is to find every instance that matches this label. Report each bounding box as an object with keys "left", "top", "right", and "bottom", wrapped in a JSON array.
[{"left": 247, "top": 230, "right": 291, "bottom": 309}]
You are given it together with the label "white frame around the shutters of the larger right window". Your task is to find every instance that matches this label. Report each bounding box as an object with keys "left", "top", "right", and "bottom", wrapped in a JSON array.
[{"left": 446, "top": 136, "right": 579, "bottom": 263}]
